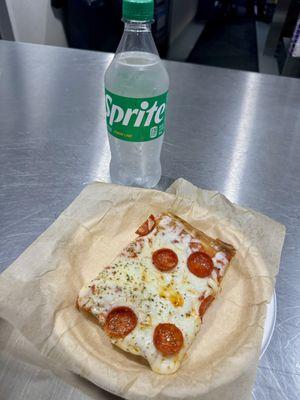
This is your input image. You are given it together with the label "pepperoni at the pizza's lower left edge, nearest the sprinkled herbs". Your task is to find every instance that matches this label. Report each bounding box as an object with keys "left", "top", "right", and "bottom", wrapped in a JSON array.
[{"left": 104, "top": 307, "right": 137, "bottom": 338}]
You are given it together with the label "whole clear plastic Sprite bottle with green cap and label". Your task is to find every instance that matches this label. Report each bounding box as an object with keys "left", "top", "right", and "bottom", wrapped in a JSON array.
[{"left": 105, "top": 0, "right": 169, "bottom": 187}]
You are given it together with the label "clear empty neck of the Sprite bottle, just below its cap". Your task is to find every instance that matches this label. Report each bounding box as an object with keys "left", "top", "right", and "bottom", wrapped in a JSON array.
[{"left": 116, "top": 20, "right": 158, "bottom": 55}]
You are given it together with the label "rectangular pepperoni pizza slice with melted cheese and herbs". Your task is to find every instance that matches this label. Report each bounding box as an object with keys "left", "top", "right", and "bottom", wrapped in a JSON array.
[{"left": 77, "top": 213, "right": 235, "bottom": 374}]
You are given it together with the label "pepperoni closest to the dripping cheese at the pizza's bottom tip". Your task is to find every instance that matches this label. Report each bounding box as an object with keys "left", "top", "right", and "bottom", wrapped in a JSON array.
[{"left": 153, "top": 324, "right": 183, "bottom": 356}]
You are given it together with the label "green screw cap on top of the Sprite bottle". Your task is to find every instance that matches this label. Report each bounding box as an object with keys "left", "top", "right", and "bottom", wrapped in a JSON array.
[{"left": 123, "top": 0, "right": 154, "bottom": 21}]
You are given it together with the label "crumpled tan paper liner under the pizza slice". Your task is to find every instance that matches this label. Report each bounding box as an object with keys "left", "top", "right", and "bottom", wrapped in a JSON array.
[{"left": 0, "top": 179, "right": 285, "bottom": 400}]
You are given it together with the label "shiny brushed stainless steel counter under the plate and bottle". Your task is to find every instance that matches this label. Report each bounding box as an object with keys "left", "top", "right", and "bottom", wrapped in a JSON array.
[{"left": 0, "top": 41, "right": 300, "bottom": 400}]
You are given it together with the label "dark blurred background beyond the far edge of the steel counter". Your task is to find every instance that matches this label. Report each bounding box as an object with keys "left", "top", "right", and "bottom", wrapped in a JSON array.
[{"left": 0, "top": 0, "right": 300, "bottom": 77}]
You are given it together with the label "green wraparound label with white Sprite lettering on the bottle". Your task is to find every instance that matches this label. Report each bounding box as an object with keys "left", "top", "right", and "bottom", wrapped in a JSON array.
[{"left": 105, "top": 89, "right": 168, "bottom": 142}]
